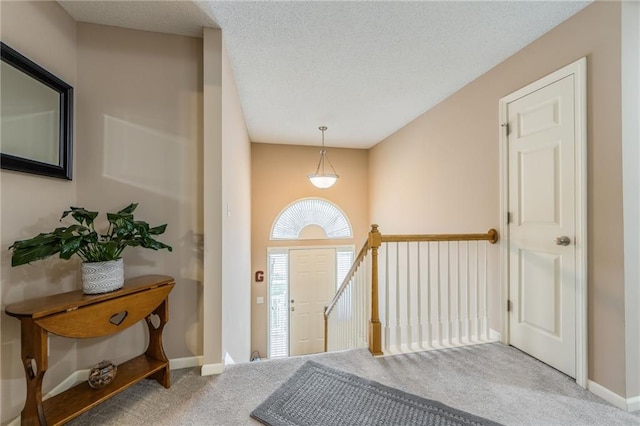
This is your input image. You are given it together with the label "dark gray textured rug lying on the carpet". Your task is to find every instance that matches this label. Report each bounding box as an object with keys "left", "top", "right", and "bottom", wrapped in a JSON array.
[{"left": 251, "top": 361, "right": 499, "bottom": 426}]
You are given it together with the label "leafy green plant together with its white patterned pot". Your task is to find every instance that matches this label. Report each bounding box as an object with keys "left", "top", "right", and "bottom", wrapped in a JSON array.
[{"left": 9, "top": 203, "right": 172, "bottom": 294}]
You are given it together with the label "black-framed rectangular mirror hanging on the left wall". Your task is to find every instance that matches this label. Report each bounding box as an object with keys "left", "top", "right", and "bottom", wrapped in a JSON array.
[{"left": 0, "top": 42, "right": 73, "bottom": 180}]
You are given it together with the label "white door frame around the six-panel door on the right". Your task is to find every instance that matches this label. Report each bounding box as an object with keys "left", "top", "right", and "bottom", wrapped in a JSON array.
[{"left": 498, "top": 57, "right": 589, "bottom": 389}]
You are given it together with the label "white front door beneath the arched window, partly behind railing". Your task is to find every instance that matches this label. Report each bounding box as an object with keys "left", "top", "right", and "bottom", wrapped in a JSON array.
[{"left": 289, "top": 249, "right": 336, "bottom": 356}]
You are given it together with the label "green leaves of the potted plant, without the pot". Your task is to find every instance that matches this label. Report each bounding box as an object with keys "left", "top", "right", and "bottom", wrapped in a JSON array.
[{"left": 9, "top": 203, "right": 173, "bottom": 266}]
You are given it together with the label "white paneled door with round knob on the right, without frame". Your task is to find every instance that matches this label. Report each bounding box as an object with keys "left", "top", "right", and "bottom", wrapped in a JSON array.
[{"left": 506, "top": 59, "right": 584, "bottom": 377}]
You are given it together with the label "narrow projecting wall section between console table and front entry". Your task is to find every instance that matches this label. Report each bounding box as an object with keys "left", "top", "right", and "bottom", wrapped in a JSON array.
[{"left": 202, "top": 28, "right": 251, "bottom": 374}]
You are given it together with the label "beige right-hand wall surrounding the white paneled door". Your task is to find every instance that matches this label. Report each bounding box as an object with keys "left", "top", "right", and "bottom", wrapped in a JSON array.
[{"left": 370, "top": 2, "right": 625, "bottom": 395}]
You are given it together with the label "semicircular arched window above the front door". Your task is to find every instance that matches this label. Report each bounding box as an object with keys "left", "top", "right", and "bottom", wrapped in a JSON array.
[{"left": 271, "top": 198, "right": 353, "bottom": 240}]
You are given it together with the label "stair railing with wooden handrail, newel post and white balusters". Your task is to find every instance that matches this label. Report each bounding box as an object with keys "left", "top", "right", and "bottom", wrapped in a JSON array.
[{"left": 325, "top": 225, "right": 498, "bottom": 355}]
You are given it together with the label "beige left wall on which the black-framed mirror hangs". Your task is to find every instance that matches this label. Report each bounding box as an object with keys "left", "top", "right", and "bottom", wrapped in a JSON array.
[{"left": 0, "top": 1, "right": 82, "bottom": 424}]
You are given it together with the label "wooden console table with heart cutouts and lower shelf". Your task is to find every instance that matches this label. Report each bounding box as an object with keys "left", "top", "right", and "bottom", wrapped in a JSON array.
[{"left": 5, "top": 275, "right": 175, "bottom": 425}]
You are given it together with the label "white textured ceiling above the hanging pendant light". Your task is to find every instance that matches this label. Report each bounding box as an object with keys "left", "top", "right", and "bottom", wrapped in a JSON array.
[{"left": 59, "top": 0, "right": 591, "bottom": 148}]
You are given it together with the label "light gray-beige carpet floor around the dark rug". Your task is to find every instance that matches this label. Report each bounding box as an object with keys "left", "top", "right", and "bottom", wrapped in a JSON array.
[{"left": 70, "top": 343, "right": 640, "bottom": 426}]
